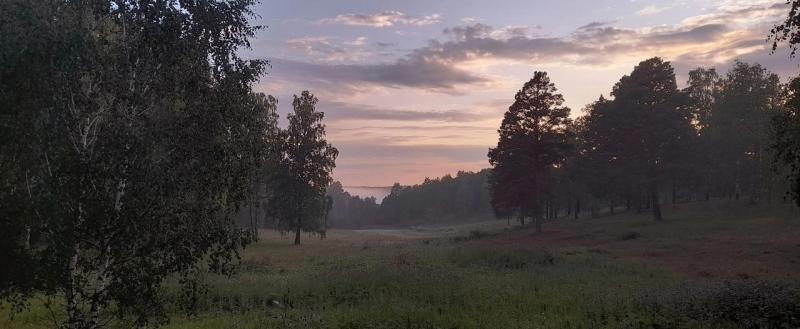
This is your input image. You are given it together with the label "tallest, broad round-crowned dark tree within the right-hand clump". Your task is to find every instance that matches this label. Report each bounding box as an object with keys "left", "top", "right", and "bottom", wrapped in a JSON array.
[{"left": 588, "top": 58, "right": 694, "bottom": 220}]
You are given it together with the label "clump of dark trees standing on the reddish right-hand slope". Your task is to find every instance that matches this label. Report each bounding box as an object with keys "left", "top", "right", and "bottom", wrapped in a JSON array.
[{"left": 489, "top": 58, "right": 800, "bottom": 229}]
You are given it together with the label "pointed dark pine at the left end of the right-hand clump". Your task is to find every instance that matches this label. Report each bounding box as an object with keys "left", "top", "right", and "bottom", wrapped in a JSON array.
[{"left": 489, "top": 72, "right": 570, "bottom": 232}]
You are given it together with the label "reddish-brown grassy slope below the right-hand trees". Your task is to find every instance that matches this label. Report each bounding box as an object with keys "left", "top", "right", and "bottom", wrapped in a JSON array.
[{"left": 470, "top": 210, "right": 800, "bottom": 279}]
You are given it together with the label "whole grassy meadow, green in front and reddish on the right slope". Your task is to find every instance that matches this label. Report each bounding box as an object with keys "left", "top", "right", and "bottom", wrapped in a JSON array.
[{"left": 0, "top": 202, "right": 800, "bottom": 328}]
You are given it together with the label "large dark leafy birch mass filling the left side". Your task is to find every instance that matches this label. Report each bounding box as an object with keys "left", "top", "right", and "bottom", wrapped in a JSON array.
[{"left": 0, "top": 0, "right": 274, "bottom": 328}]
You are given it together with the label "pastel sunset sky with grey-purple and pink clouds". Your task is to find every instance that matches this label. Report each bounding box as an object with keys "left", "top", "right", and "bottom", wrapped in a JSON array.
[{"left": 244, "top": 0, "right": 800, "bottom": 186}]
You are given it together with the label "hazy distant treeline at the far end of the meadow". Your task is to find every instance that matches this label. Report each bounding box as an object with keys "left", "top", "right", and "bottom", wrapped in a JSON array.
[{"left": 328, "top": 169, "right": 492, "bottom": 228}]
